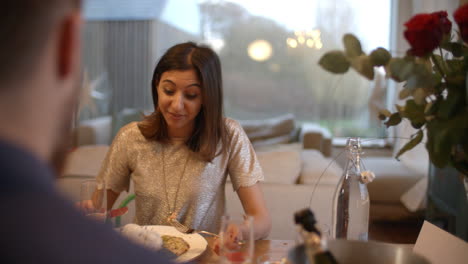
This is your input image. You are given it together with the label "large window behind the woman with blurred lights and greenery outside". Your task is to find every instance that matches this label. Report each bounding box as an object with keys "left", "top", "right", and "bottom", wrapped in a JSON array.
[{"left": 80, "top": 0, "right": 391, "bottom": 144}]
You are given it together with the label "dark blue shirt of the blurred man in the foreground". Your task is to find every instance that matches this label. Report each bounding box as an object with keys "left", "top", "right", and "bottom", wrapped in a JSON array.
[{"left": 0, "top": 140, "right": 175, "bottom": 264}]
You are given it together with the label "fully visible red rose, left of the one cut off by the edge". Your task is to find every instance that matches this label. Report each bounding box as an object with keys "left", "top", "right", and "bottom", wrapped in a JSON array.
[{"left": 404, "top": 14, "right": 444, "bottom": 57}]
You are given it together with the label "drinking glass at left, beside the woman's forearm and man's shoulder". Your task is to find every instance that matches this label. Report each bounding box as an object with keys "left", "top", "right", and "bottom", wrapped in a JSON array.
[{"left": 79, "top": 180, "right": 107, "bottom": 223}]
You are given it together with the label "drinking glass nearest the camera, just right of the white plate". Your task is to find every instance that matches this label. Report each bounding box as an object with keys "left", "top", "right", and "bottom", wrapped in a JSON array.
[{"left": 219, "top": 215, "right": 254, "bottom": 264}]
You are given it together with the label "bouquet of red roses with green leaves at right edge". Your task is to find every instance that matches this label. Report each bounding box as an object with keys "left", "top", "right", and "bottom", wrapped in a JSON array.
[{"left": 319, "top": 4, "right": 468, "bottom": 176}]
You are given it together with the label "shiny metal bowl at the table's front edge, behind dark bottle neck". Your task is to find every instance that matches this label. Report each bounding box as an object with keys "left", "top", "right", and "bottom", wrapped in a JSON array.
[{"left": 288, "top": 239, "right": 430, "bottom": 264}]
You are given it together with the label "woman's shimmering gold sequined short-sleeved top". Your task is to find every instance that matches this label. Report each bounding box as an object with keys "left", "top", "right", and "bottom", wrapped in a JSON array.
[{"left": 98, "top": 118, "right": 263, "bottom": 232}]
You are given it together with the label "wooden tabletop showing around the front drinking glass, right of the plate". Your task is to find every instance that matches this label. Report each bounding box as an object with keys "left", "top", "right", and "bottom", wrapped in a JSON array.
[{"left": 193, "top": 238, "right": 296, "bottom": 264}]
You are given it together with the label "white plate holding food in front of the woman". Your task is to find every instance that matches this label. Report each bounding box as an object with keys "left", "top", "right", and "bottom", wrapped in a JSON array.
[{"left": 144, "top": 225, "right": 208, "bottom": 262}]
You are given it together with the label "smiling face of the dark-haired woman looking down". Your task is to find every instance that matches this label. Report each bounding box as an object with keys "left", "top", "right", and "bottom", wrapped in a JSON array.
[{"left": 157, "top": 70, "right": 203, "bottom": 137}]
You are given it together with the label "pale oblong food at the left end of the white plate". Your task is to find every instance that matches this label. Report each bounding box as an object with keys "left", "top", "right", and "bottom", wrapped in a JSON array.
[{"left": 121, "top": 224, "right": 163, "bottom": 250}]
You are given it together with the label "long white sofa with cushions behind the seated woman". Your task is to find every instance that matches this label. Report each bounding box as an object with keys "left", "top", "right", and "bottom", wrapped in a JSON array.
[{"left": 57, "top": 115, "right": 342, "bottom": 239}]
